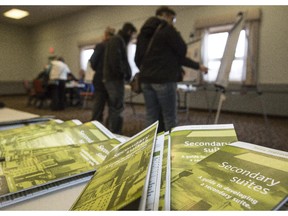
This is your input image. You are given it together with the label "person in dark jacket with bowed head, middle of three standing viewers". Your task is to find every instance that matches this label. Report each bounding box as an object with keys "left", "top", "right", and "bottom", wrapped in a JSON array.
[{"left": 103, "top": 23, "right": 136, "bottom": 134}]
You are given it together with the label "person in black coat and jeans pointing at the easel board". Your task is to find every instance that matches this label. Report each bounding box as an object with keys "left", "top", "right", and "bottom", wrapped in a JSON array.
[{"left": 135, "top": 7, "right": 207, "bottom": 132}]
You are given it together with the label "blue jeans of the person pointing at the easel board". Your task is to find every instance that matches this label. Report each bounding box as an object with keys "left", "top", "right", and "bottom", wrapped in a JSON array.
[{"left": 141, "top": 82, "right": 177, "bottom": 132}]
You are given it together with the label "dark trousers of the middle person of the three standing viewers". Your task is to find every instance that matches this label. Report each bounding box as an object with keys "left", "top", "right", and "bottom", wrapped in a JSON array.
[{"left": 104, "top": 80, "right": 124, "bottom": 134}]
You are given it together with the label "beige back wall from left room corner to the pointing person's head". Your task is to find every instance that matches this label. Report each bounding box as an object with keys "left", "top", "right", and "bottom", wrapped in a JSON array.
[{"left": 29, "top": 6, "right": 159, "bottom": 75}]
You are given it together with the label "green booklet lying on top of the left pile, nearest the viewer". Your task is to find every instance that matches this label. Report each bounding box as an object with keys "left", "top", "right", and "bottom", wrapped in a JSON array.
[{"left": 0, "top": 139, "right": 120, "bottom": 207}]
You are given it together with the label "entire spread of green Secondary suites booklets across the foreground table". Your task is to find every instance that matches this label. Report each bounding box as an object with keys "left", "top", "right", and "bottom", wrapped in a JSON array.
[{"left": 0, "top": 120, "right": 288, "bottom": 211}]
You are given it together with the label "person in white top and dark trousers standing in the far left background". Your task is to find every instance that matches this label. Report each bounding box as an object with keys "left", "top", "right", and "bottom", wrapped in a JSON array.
[{"left": 49, "top": 57, "right": 71, "bottom": 110}]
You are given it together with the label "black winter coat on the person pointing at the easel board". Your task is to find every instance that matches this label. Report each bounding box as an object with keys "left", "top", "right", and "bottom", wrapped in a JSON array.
[{"left": 135, "top": 17, "right": 199, "bottom": 83}]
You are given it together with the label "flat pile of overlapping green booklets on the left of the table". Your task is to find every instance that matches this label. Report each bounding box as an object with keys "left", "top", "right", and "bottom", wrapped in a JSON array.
[{"left": 0, "top": 120, "right": 123, "bottom": 207}]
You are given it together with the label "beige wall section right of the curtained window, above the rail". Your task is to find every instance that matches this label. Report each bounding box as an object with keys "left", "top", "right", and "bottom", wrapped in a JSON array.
[{"left": 259, "top": 6, "right": 288, "bottom": 84}]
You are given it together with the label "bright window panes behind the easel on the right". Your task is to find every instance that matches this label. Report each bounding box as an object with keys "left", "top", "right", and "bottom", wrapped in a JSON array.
[{"left": 204, "top": 27, "right": 247, "bottom": 83}]
